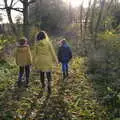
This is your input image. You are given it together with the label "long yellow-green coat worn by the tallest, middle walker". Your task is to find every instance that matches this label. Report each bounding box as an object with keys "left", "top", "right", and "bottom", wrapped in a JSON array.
[{"left": 34, "top": 39, "right": 57, "bottom": 72}]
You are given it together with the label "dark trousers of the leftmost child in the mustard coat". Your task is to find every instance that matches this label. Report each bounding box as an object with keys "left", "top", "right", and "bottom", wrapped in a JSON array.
[{"left": 18, "top": 65, "right": 30, "bottom": 84}]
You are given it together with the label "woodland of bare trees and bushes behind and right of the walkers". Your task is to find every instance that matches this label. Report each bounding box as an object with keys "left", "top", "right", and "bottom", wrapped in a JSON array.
[{"left": 0, "top": 0, "right": 120, "bottom": 120}]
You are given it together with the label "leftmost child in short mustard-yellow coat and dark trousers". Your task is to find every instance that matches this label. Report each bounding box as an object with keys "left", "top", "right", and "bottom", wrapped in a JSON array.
[{"left": 15, "top": 38, "right": 32, "bottom": 87}]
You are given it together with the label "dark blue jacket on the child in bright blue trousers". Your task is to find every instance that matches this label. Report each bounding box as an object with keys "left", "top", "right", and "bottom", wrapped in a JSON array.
[{"left": 58, "top": 43, "right": 72, "bottom": 63}]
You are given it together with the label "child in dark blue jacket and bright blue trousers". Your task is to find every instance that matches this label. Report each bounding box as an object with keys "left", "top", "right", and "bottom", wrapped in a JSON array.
[{"left": 58, "top": 39, "right": 72, "bottom": 79}]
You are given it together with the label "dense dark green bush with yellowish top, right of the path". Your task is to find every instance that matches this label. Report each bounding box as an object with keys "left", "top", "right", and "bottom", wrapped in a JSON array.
[{"left": 88, "top": 30, "right": 120, "bottom": 120}]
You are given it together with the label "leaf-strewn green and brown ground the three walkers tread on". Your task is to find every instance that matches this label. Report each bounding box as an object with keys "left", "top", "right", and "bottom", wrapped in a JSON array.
[{"left": 0, "top": 57, "right": 109, "bottom": 120}]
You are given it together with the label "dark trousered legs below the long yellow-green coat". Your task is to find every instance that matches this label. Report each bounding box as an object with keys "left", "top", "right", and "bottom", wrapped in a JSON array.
[{"left": 40, "top": 72, "right": 52, "bottom": 93}]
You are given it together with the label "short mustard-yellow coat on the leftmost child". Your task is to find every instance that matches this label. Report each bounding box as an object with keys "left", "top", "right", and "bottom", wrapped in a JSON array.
[{"left": 15, "top": 45, "right": 32, "bottom": 66}]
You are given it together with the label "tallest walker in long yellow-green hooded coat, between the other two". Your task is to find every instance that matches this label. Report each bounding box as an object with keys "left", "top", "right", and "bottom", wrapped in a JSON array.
[{"left": 34, "top": 31, "right": 57, "bottom": 94}]
